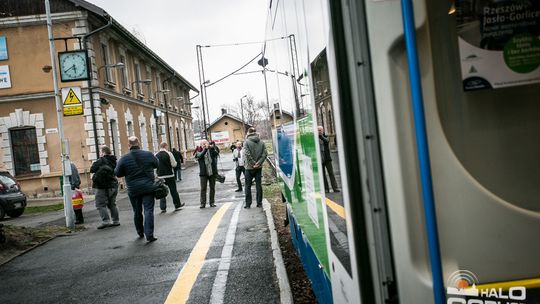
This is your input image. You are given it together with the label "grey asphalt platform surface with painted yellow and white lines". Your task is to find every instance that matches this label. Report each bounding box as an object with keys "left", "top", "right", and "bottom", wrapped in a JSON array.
[{"left": 0, "top": 154, "right": 280, "bottom": 304}]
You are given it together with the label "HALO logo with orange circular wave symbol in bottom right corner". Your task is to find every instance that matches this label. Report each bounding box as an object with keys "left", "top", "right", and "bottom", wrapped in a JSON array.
[{"left": 446, "top": 270, "right": 527, "bottom": 304}]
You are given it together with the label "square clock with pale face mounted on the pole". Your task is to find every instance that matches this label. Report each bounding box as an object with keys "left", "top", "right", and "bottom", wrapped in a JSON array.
[{"left": 58, "top": 50, "right": 88, "bottom": 82}]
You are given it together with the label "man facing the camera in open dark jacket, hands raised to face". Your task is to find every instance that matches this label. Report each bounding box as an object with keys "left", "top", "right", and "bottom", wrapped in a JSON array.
[{"left": 195, "top": 140, "right": 219, "bottom": 209}]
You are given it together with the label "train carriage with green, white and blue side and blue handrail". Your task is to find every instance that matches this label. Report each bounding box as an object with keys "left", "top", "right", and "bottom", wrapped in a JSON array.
[{"left": 263, "top": 0, "right": 540, "bottom": 304}]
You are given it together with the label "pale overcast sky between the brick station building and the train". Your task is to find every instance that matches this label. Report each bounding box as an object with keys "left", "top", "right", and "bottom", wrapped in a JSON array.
[{"left": 87, "top": 0, "right": 269, "bottom": 121}]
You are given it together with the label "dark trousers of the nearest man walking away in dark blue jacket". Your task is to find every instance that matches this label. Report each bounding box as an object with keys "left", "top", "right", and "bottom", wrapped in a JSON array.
[{"left": 129, "top": 193, "right": 156, "bottom": 239}]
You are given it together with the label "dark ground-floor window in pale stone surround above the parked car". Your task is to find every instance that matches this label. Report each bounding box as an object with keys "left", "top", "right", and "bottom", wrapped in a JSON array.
[{"left": 9, "top": 127, "right": 41, "bottom": 176}]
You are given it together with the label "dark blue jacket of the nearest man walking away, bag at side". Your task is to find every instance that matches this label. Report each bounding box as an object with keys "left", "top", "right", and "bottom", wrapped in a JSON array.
[{"left": 114, "top": 147, "right": 158, "bottom": 196}]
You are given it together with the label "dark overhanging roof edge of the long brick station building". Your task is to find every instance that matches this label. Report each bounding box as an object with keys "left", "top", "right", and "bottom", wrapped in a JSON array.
[{"left": 67, "top": 0, "right": 199, "bottom": 93}]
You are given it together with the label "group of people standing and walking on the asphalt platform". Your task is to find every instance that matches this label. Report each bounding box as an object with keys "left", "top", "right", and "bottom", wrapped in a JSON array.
[{"left": 70, "top": 128, "right": 267, "bottom": 242}]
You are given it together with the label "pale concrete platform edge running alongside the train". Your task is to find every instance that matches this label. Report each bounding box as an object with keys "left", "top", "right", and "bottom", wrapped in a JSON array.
[{"left": 263, "top": 199, "right": 293, "bottom": 304}]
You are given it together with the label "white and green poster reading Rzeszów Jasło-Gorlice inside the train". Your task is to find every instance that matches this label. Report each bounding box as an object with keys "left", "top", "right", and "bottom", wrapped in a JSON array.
[{"left": 456, "top": 0, "right": 540, "bottom": 91}]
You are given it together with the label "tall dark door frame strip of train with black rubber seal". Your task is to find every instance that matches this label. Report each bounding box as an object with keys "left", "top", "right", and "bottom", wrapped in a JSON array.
[{"left": 323, "top": 1, "right": 397, "bottom": 303}]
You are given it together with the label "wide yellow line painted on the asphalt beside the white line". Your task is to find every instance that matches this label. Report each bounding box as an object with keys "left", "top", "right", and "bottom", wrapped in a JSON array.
[{"left": 165, "top": 203, "right": 232, "bottom": 304}]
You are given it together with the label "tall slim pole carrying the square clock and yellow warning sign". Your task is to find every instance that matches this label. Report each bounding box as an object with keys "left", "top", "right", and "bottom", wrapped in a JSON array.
[{"left": 45, "top": 0, "right": 75, "bottom": 229}]
